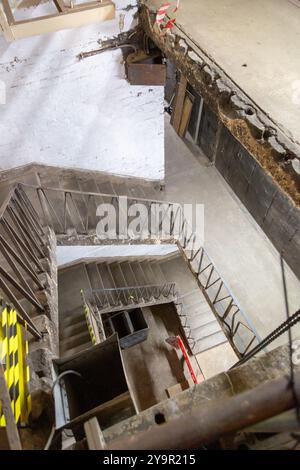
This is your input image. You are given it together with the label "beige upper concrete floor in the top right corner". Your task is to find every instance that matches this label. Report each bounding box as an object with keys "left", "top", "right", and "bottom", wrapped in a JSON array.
[{"left": 146, "top": 0, "right": 300, "bottom": 142}]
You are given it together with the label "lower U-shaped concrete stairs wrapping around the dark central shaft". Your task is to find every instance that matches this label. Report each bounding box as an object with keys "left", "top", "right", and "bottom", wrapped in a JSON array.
[{"left": 58, "top": 255, "right": 227, "bottom": 355}]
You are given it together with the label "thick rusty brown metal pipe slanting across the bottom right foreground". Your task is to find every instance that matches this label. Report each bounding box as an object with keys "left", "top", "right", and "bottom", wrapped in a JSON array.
[{"left": 107, "top": 371, "right": 300, "bottom": 450}]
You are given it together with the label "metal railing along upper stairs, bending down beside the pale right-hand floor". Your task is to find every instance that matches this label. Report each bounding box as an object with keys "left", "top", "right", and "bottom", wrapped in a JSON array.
[{"left": 15, "top": 185, "right": 261, "bottom": 358}]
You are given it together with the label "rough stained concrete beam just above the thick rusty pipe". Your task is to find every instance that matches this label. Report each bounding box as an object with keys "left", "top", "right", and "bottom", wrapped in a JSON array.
[{"left": 103, "top": 346, "right": 299, "bottom": 448}]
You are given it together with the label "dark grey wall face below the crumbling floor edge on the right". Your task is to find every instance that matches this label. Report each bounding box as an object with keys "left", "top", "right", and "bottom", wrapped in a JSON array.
[{"left": 186, "top": 91, "right": 300, "bottom": 278}]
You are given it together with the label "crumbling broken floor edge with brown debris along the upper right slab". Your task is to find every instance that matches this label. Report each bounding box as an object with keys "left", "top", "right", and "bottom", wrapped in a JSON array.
[{"left": 140, "top": 2, "right": 300, "bottom": 206}]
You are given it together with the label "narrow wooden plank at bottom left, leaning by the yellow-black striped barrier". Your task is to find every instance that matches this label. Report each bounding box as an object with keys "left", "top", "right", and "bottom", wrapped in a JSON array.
[{"left": 0, "top": 364, "right": 22, "bottom": 450}]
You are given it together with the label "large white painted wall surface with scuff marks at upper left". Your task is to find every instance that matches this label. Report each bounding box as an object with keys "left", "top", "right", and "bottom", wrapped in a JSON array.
[{"left": 0, "top": 0, "right": 164, "bottom": 179}]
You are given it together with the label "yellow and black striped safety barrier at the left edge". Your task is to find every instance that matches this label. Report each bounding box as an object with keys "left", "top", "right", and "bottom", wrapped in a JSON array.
[{"left": 0, "top": 305, "right": 31, "bottom": 427}]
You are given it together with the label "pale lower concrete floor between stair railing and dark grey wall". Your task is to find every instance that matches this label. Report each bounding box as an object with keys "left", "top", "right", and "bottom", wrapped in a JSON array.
[{"left": 165, "top": 116, "right": 300, "bottom": 347}]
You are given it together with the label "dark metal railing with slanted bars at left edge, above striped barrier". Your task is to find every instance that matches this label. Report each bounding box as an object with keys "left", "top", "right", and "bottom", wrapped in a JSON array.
[{"left": 0, "top": 185, "right": 47, "bottom": 338}]
